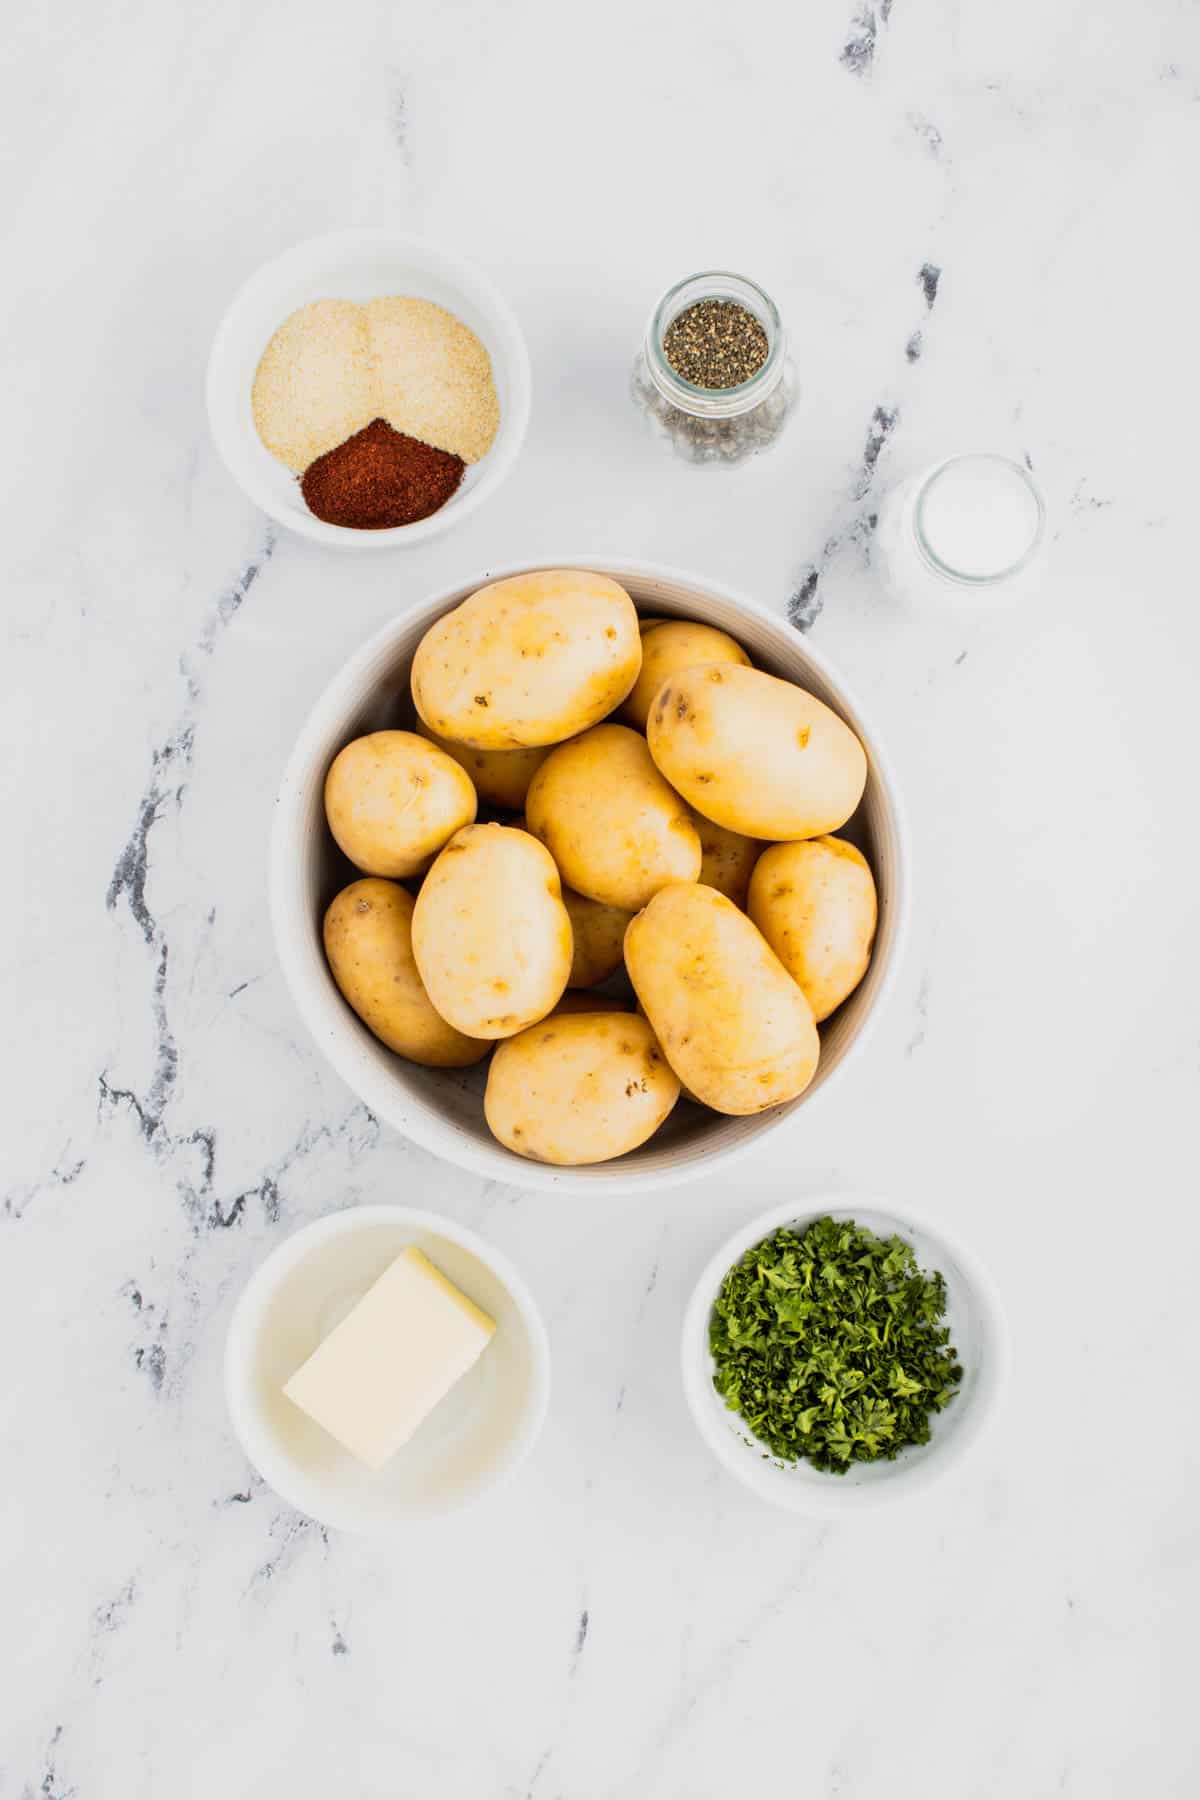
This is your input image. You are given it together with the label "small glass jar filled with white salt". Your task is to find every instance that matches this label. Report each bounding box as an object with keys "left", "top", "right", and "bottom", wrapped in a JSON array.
[{"left": 873, "top": 452, "right": 1045, "bottom": 607}]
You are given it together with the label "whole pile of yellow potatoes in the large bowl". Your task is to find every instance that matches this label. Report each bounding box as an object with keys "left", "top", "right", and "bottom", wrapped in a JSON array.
[{"left": 324, "top": 569, "right": 876, "bottom": 1163}]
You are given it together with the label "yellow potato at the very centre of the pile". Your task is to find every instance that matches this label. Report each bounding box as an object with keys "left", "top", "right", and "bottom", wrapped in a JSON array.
[{"left": 525, "top": 725, "right": 700, "bottom": 913}]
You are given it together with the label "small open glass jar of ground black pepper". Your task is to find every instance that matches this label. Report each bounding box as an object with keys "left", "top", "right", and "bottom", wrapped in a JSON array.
[{"left": 633, "top": 270, "right": 797, "bottom": 463}]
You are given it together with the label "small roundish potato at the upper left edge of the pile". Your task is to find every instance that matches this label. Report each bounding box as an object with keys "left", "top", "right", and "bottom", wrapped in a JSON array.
[{"left": 326, "top": 731, "right": 477, "bottom": 880}]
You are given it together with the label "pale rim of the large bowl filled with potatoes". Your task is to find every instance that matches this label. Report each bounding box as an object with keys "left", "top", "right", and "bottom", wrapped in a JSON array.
[{"left": 268, "top": 554, "right": 910, "bottom": 1193}]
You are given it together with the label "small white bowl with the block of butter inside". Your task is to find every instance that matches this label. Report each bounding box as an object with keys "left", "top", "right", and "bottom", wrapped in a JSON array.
[{"left": 225, "top": 1206, "right": 551, "bottom": 1537}]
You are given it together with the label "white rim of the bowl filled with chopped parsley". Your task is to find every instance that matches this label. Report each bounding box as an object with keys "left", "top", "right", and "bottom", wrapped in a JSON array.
[{"left": 680, "top": 1193, "right": 1011, "bottom": 1517}]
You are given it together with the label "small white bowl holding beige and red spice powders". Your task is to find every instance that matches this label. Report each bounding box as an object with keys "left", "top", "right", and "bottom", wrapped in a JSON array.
[{"left": 207, "top": 230, "right": 533, "bottom": 551}]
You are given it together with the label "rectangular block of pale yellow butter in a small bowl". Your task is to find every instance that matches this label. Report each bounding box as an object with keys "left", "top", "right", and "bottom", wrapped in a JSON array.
[{"left": 282, "top": 1246, "right": 497, "bottom": 1469}]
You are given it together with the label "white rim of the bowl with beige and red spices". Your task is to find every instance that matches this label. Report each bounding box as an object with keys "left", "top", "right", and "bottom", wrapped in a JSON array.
[{"left": 205, "top": 225, "right": 533, "bottom": 551}]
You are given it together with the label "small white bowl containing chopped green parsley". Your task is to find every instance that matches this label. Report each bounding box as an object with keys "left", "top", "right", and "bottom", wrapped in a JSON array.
[{"left": 682, "top": 1195, "right": 1007, "bottom": 1517}]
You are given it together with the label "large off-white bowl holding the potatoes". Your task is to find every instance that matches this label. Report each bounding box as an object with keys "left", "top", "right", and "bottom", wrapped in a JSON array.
[{"left": 270, "top": 556, "right": 909, "bottom": 1192}]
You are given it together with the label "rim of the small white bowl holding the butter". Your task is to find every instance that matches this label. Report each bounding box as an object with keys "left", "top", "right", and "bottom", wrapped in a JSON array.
[{"left": 223, "top": 1202, "right": 551, "bottom": 1537}]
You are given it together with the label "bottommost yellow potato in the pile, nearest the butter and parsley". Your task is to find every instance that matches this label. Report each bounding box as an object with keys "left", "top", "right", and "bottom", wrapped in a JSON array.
[{"left": 484, "top": 1012, "right": 678, "bottom": 1166}]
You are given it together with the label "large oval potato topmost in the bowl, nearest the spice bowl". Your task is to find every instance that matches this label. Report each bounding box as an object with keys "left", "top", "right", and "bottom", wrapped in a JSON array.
[{"left": 412, "top": 569, "right": 642, "bottom": 751}]
